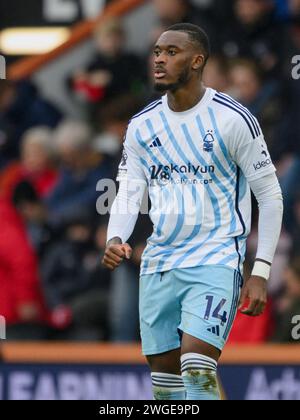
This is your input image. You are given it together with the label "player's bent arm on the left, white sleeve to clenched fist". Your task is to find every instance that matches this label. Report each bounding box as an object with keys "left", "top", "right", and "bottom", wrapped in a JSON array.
[{"left": 102, "top": 126, "right": 147, "bottom": 270}]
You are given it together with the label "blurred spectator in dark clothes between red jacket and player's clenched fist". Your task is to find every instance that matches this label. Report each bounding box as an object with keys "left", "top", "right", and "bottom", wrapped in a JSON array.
[{"left": 42, "top": 215, "right": 110, "bottom": 341}]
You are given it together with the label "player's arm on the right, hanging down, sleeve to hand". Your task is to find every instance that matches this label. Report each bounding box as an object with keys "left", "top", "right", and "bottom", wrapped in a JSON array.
[{"left": 233, "top": 116, "right": 283, "bottom": 316}]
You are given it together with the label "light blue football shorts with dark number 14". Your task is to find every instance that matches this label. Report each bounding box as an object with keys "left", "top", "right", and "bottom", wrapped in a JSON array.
[{"left": 140, "top": 266, "right": 243, "bottom": 356}]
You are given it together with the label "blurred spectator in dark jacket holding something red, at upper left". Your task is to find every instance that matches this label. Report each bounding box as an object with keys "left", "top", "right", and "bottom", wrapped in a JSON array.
[{"left": 72, "top": 19, "right": 144, "bottom": 123}]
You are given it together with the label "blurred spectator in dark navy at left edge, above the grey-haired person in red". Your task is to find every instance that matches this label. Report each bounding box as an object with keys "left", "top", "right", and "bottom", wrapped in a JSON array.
[{"left": 0, "top": 81, "right": 62, "bottom": 166}]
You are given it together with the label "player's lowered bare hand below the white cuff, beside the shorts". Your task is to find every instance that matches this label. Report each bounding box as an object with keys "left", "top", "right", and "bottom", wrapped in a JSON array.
[{"left": 239, "top": 276, "right": 268, "bottom": 317}]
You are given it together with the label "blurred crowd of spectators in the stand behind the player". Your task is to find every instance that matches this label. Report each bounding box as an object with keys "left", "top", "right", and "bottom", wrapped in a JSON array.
[{"left": 0, "top": 0, "right": 300, "bottom": 343}]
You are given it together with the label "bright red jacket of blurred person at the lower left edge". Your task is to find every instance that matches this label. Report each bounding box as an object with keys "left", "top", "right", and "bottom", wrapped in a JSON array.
[{"left": 0, "top": 199, "right": 44, "bottom": 339}]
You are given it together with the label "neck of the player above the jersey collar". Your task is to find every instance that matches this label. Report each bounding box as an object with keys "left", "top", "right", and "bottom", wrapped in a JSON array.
[{"left": 167, "top": 83, "right": 206, "bottom": 112}]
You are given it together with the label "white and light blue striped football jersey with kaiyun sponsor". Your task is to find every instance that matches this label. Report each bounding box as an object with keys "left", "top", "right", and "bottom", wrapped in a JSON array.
[{"left": 118, "top": 88, "right": 276, "bottom": 275}]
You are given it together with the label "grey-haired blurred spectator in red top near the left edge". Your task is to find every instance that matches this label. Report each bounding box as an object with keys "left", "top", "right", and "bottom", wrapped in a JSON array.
[{"left": 0, "top": 127, "right": 57, "bottom": 199}]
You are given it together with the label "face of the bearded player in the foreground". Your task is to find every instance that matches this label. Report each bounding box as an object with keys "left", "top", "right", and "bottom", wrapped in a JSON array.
[{"left": 154, "top": 31, "right": 197, "bottom": 92}]
